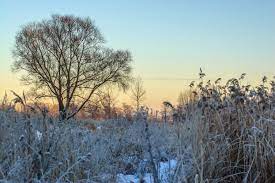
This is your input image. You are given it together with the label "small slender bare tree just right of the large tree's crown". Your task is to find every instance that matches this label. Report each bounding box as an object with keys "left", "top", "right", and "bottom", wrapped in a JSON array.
[{"left": 131, "top": 77, "right": 146, "bottom": 111}]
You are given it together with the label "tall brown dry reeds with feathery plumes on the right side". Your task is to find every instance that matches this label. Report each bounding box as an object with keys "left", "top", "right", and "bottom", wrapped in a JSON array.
[{"left": 182, "top": 75, "right": 275, "bottom": 182}]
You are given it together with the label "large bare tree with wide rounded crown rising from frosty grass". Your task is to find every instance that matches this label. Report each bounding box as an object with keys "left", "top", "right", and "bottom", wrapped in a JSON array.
[{"left": 13, "top": 15, "right": 132, "bottom": 119}]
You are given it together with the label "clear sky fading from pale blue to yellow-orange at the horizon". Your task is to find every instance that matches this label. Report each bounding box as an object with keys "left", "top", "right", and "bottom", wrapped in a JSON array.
[{"left": 0, "top": 0, "right": 275, "bottom": 107}]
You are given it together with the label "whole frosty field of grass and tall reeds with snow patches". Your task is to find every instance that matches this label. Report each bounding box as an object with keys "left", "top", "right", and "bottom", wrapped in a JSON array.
[{"left": 0, "top": 75, "right": 275, "bottom": 183}]
